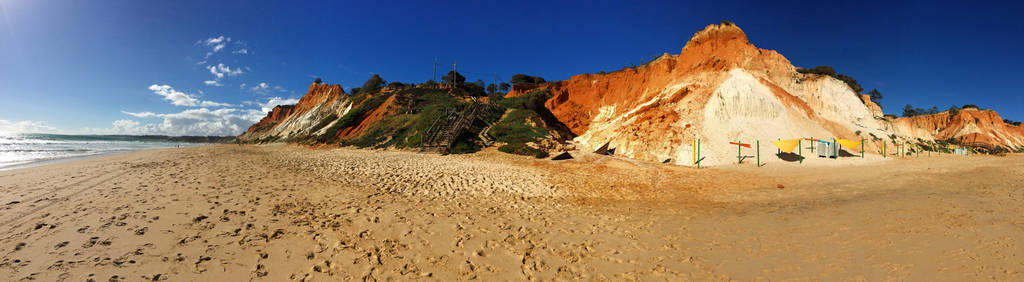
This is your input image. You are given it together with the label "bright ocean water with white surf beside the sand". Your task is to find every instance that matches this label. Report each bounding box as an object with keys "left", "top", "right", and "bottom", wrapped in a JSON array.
[{"left": 0, "top": 133, "right": 199, "bottom": 170}]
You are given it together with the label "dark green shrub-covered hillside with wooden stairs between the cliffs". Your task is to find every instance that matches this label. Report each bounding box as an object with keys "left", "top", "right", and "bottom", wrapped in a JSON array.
[{"left": 266, "top": 76, "right": 564, "bottom": 157}]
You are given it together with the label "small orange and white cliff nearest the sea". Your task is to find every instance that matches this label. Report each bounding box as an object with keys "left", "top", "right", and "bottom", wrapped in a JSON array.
[{"left": 239, "top": 83, "right": 352, "bottom": 143}]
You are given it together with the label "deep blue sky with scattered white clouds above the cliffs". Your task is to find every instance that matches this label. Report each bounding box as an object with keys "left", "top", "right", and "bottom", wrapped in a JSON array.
[{"left": 0, "top": 0, "right": 1024, "bottom": 135}]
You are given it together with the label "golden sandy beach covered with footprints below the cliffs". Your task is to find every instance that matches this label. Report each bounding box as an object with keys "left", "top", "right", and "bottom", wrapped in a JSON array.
[{"left": 0, "top": 145, "right": 1024, "bottom": 281}]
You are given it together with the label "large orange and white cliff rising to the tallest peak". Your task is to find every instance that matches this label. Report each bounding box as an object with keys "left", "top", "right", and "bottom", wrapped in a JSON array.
[{"left": 524, "top": 24, "right": 1021, "bottom": 165}]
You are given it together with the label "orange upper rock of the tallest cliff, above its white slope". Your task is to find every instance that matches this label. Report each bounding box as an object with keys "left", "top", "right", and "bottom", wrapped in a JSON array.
[{"left": 548, "top": 25, "right": 796, "bottom": 134}]
